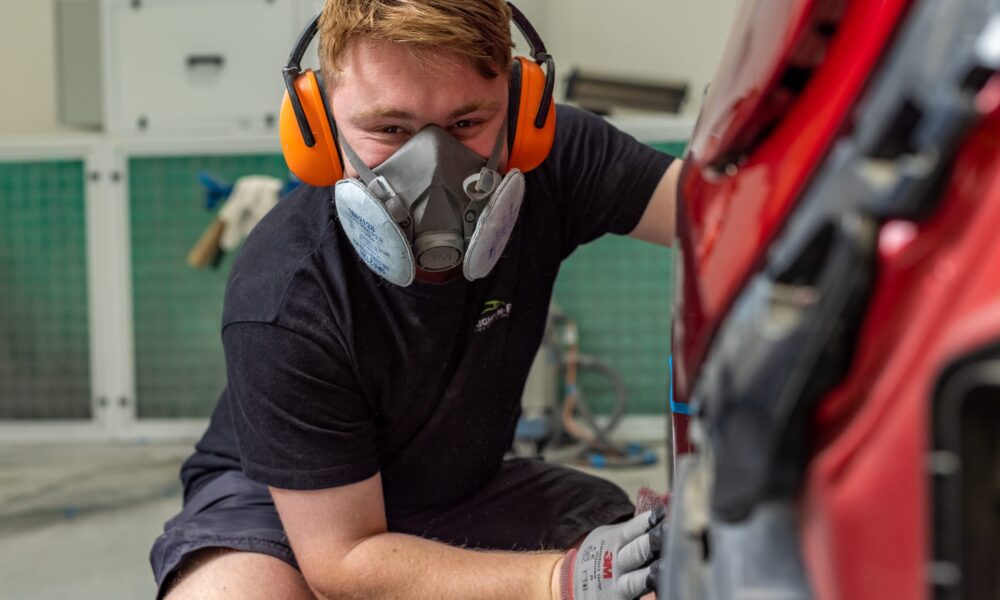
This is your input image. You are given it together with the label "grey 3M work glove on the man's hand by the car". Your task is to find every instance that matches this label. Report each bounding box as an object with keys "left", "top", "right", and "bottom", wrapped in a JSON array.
[{"left": 560, "top": 505, "right": 667, "bottom": 600}]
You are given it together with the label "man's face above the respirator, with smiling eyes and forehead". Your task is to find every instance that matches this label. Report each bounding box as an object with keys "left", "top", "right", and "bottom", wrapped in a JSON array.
[{"left": 329, "top": 38, "right": 508, "bottom": 177}]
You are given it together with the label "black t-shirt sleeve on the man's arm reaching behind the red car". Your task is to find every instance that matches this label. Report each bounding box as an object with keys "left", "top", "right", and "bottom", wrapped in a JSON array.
[{"left": 552, "top": 106, "right": 674, "bottom": 257}]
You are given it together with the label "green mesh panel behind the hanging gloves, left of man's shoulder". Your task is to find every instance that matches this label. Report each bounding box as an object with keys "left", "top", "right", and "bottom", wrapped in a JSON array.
[{"left": 129, "top": 155, "right": 288, "bottom": 418}]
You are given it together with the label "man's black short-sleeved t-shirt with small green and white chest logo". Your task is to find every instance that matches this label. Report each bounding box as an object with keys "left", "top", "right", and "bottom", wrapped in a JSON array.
[{"left": 185, "top": 106, "right": 671, "bottom": 515}]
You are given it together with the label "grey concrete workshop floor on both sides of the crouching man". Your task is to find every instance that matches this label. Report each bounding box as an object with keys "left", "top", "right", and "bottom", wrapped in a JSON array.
[{"left": 0, "top": 443, "right": 667, "bottom": 600}]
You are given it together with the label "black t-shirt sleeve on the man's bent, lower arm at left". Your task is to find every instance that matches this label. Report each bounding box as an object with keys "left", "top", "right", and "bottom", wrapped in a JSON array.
[{"left": 222, "top": 322, "right": 379, "bottom": 490}]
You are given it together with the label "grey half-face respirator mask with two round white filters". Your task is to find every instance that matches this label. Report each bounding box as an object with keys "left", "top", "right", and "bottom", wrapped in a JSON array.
[{"left": 334, "top": 125, "right": 524, "bottom": 286}]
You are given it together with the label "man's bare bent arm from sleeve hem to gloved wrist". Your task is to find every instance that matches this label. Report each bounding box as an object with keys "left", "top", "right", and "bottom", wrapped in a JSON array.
[{"left": 271, "top": 475, "right": 562, "bottom": 600}]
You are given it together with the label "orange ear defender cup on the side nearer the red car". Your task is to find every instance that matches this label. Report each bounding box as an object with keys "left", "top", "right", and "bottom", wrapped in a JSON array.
[{"left": 507, "top": 56, "right": 556, "bottom": 173}]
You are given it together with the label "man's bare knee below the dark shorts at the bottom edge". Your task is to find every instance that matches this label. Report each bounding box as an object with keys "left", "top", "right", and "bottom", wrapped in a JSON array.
[{"left": 164, "top": 548, "right": 316, "bottom": 600}]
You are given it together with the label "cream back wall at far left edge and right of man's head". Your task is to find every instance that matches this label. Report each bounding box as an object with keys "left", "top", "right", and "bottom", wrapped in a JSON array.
[{"left": 0, "top": 0, "right": 741, "bottom": 135}]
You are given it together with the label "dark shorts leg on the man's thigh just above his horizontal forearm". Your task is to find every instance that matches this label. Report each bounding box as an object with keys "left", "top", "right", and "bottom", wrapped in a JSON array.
[{"left": 389, "top": 459, "right": 635, "bottom": 550}]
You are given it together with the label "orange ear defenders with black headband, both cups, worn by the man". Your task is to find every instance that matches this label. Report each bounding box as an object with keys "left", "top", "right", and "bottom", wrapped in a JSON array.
[{"left": 278, "top": 2, "right": 556, "bottom": 187}]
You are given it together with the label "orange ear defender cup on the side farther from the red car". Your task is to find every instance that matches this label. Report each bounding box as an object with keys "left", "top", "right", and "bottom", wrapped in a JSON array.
[{"left": 278, "top": 69, "right": 344, "bottom": 187}]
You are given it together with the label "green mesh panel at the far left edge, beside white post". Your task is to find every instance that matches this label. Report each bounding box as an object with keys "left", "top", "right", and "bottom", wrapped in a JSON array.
[{"left": 0, "top": 161, "right": 91, "bottom": 420}]
